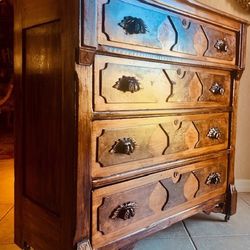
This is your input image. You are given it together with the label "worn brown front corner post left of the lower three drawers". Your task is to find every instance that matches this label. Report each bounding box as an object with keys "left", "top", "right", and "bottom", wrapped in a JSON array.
[{"left": 74, "top": 66, "right": 92, "bottom": 243}]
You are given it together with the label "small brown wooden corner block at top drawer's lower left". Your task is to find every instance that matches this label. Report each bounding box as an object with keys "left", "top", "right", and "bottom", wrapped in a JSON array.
[{"left": 76, "top": 47, "right": 96, "bottom": 66}]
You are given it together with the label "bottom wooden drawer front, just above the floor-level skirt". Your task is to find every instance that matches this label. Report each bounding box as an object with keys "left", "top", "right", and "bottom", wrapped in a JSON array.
[{"left": 92, "top": 156, "right": 227, "bottom": 247}]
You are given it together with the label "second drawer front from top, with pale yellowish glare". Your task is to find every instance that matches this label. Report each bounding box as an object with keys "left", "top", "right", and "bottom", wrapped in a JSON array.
[{"left": 94, "top": 56, "right": 231, "bottom": 111}]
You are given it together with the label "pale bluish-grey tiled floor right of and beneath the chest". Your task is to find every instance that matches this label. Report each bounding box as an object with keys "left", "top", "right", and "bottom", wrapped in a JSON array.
[{"left": 134, "top": 193, "right": 250, "bottom": 250}]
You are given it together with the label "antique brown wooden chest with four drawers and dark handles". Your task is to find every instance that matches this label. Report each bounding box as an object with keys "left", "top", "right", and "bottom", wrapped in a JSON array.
[{"left": 15, "top": 0, "right": 248, "bottom": 250}]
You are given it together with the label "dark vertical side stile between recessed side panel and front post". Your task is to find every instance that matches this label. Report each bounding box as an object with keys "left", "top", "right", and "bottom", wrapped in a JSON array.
[{"left": 58, "top": 0, "right": 79, "bottom": 250}]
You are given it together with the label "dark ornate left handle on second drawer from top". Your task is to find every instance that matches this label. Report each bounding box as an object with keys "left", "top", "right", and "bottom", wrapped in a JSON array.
[{"left": 113, "top": 76, "right": 142, "bottom": 93}]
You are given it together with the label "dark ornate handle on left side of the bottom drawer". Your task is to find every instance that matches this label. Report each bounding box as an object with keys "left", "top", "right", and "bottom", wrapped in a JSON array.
[{"left": 111, "top": 201, "right": 137, "bottom": 220}]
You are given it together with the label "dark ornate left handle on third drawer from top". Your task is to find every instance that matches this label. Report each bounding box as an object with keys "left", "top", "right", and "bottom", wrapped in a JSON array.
[{"left": 110, "top": 138, "right": 136, "bottom": 155}]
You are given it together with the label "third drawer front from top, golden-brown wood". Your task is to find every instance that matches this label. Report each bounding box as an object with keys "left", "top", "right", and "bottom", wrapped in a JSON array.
[{"left": 92, "top": 113, "right": 228, "bottom": 177}]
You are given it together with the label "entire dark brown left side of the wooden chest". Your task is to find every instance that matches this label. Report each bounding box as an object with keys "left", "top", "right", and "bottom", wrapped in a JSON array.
[{"left": 14, "top": 0, "right": 78, "bottom": 250}]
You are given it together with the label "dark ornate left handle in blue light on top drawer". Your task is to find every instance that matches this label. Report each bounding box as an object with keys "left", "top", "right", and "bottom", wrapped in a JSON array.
[{"left": 118, "top": 16, "right": 148, "bottom": 35}]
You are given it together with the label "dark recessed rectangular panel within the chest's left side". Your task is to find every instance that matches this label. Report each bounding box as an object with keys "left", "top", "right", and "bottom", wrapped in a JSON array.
[{"left": 23, "top": 21, "right": 62, "bottom": 214}]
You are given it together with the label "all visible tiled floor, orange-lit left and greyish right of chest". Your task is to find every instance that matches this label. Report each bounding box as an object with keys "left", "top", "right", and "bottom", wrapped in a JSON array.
[{"left": 0, "top": 160, "right": 250, "bottom": 250}]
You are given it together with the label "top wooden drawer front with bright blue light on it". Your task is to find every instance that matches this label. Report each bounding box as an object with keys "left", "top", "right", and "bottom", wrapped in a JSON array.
[{"left": 98, "top": 0, "right": 236, "bottom": 65}]
